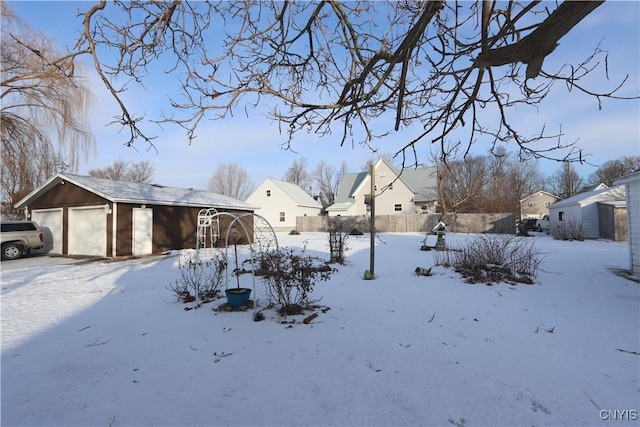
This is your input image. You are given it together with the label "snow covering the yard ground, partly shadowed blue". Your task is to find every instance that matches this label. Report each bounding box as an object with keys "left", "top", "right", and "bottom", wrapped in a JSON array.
[{"left": 1, "top": 233, "right": 640, "bottom": 426}]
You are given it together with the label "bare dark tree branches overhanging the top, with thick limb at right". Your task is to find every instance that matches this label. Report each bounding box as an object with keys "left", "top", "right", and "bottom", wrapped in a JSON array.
[{"left": 33, "top": 0, "right": 636, "bottom": 165}]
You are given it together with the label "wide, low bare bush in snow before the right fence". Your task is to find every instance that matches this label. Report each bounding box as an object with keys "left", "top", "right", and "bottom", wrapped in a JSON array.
[{"left": 434, "top": 234, "right": 542, "bottom": 284}]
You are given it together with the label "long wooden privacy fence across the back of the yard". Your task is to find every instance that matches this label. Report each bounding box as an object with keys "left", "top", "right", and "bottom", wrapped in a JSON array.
[{"left": 296, "top": 213, "right": 516, "bottom": 234}]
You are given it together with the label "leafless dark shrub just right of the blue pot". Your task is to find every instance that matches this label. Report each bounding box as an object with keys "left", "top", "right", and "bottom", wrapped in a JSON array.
[{"left": 260, "top": 248, "right": 335, "bottom": 315}]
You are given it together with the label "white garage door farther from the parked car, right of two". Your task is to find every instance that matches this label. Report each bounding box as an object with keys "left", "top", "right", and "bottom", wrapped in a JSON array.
[{"left": 69, "top": 206, "right": 107, "bottom": 257}]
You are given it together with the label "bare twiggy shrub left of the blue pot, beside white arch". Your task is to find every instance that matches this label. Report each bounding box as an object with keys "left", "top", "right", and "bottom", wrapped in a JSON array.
[{"left": 168, "top": 251, "right": 227, "bottom": 303}]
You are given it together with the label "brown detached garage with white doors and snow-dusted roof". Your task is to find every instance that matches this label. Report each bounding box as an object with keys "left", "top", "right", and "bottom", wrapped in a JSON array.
[{"left": 16, "top": 174, "right": 254, "bottom": 257}]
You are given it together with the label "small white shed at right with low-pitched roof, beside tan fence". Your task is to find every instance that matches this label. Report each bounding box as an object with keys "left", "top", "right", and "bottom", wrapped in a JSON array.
[{"left": 549, "top": 185, "right": 625, "bottom": 239}]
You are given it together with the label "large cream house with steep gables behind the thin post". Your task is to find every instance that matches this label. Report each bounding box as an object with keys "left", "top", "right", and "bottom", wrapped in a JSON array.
[{"left": 327, "top": 158, "right": 438, "bottom": 216}]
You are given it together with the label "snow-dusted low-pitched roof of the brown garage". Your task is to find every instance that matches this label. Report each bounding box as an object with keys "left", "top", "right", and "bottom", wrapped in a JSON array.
[{"left": 16, "top": 173, "right": 255, "bottom": 210}]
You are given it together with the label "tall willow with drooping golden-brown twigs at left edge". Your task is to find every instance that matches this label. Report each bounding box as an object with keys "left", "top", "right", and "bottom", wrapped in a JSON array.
[{"left": 0, "top": 6, "right": 94, "bottom": 216}]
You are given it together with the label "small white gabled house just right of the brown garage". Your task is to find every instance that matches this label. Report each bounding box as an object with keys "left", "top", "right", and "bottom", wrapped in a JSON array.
[{"left": 246, "top": 178, "right": 322, "bottom": 231}]
